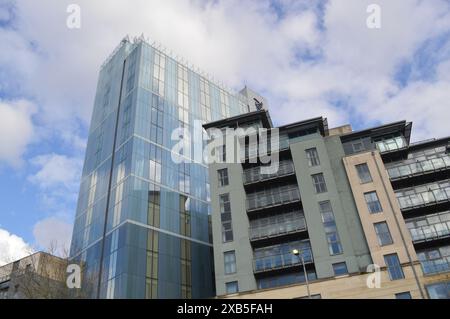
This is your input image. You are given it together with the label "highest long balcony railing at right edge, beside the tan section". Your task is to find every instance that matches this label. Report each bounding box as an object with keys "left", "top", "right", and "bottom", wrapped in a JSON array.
[{"left": 388, "top": 155, "right": 450, "bottom": 180}]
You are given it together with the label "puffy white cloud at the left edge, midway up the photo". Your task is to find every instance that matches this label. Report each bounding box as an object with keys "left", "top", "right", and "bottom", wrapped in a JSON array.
[{"left": 0, "top": 100, "right": 36, "bottom": 167}]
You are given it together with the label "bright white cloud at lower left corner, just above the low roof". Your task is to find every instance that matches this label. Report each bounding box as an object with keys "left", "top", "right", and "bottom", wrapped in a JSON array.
[{"left": 0, "top": 228, "right": 33, "bottom": 266}]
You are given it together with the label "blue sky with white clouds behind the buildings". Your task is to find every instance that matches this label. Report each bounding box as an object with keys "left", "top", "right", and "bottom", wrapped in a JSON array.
[{"left": 0, "top": 0, "right": 450, "bottom": 265}]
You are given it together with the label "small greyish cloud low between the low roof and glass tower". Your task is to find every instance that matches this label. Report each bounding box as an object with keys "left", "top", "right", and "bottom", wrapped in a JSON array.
[{"left": 33, "top": 216, "right": 73, "bottom": 257}]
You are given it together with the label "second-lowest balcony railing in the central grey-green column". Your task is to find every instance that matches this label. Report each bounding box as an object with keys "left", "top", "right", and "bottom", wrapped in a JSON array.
[{"left": 249, "top": 218, "right": 306, "bottom": 241}]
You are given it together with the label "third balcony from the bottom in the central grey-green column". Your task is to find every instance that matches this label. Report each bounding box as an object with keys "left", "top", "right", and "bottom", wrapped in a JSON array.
[{"left": 246, "top": 185, "right": 300, "bottom": 212}]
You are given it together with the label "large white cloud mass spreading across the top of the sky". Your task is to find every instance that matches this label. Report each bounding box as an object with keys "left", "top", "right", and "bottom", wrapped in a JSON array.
[{"left": 0, "top": 0, "right": 450, "bottom": 148}]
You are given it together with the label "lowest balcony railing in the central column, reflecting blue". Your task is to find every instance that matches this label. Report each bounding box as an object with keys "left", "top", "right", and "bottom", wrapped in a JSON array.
[{"left": 253, "top": 249, "right": 313, "bottom": 273}]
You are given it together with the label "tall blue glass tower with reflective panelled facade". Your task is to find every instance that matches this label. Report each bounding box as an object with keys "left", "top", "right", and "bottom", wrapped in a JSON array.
[{"left": 70, "top": 39, "right": 256, "bottom": 298}]
